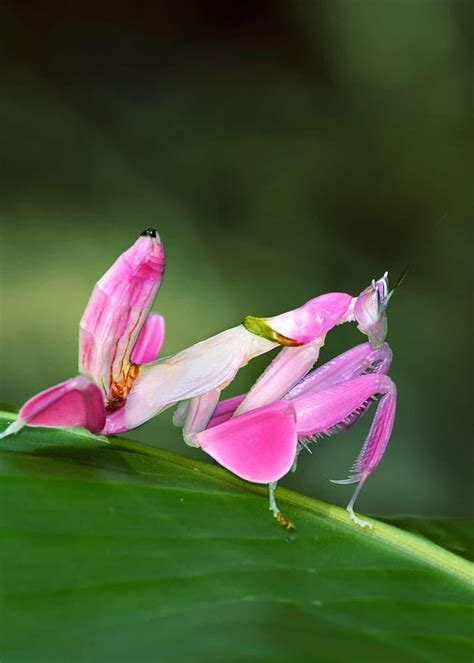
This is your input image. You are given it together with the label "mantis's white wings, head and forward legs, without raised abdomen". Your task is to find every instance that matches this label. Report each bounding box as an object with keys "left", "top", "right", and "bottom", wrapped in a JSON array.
[{"left": 124, "top": 274, "right": 396, "bottom": 526}]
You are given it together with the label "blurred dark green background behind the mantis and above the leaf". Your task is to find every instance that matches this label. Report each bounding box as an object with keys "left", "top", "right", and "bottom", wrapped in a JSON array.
[{"left": 0, "top": 0, "right": 473, "bottom": 515}]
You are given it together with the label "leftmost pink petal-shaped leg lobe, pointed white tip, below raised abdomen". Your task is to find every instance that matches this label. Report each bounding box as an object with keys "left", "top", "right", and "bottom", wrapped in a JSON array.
[{"left": 0, "top": 375, "right": 105, "bottom": 435}]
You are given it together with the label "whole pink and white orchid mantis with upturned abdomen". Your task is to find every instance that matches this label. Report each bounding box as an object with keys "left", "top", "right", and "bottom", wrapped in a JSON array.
[{"left": 0, "top": 228, "right": 396, "bottom": 527}]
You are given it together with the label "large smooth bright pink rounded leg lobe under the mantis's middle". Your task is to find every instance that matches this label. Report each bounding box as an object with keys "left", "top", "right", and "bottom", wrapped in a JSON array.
[{"left": 194, "top": 401, "right": 297, "bottom": 483}]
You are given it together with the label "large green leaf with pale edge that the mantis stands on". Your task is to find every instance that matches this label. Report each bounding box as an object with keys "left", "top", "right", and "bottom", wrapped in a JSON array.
[{"left": 0, "top": 414, "right": 473, "bottom": 663}]
